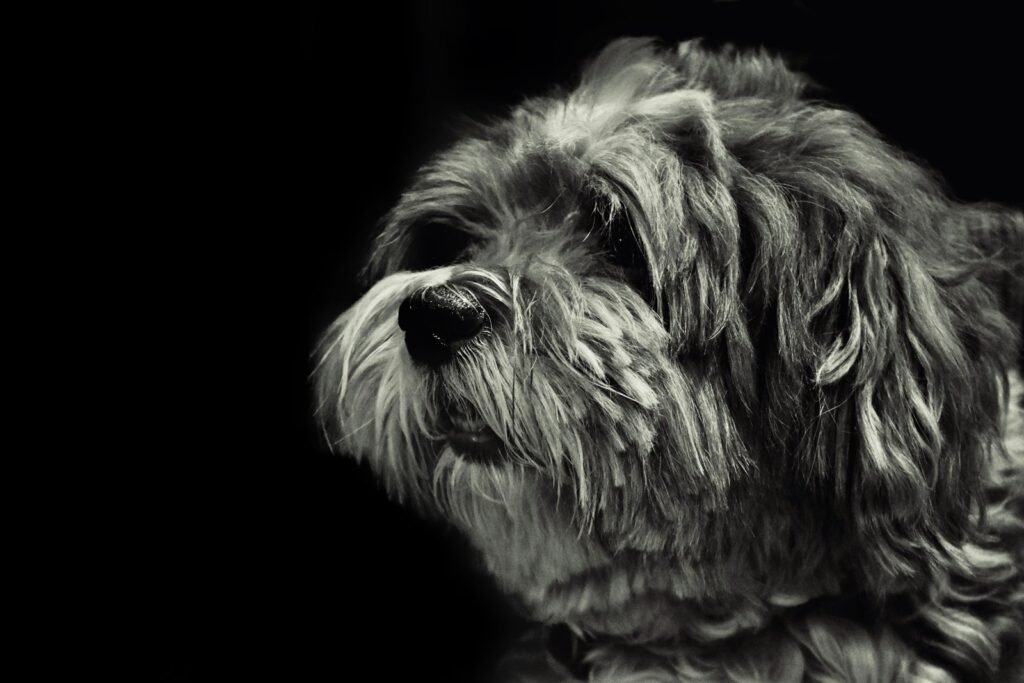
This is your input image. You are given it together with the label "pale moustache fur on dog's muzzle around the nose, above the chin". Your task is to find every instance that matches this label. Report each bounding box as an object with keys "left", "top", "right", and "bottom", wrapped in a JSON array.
[{"left": 319, "top": 268, "right": 671, "bottom": 501}]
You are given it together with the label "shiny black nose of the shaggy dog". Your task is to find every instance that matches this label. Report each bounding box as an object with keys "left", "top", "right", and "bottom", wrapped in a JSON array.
[{"left": 398, "top": 285, "right": 485, "bottom": 368}]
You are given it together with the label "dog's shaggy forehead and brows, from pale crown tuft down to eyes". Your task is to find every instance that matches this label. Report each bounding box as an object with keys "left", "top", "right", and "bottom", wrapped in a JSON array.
[{"left": 372, "top": 44, "right": 719, "bottom": 272}]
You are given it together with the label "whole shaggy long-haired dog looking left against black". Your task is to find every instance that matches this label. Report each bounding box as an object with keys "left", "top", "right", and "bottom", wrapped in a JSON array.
[{"left": 314, "top": 40, "right": 1024, "bottom": 682}]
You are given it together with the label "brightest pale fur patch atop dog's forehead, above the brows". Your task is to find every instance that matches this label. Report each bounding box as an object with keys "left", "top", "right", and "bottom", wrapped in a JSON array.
[{"left": 403, "top": 43, "right": 711, "bottom": 212}]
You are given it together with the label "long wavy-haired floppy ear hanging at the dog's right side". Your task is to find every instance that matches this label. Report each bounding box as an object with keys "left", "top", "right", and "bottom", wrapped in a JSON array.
[{"left": 746, "top": 157, "right": 1015, "bottom": 594}]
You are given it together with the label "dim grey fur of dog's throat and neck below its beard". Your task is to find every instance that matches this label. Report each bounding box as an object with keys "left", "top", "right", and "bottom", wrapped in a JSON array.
[{"left": 463, "top": 466, "right": 838, "bottom": 642}]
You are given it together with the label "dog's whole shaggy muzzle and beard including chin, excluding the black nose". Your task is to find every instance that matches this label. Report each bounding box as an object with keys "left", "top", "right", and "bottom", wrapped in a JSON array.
[{"left": 317, "top": 264, "right": 753, "bottom": 618}]
